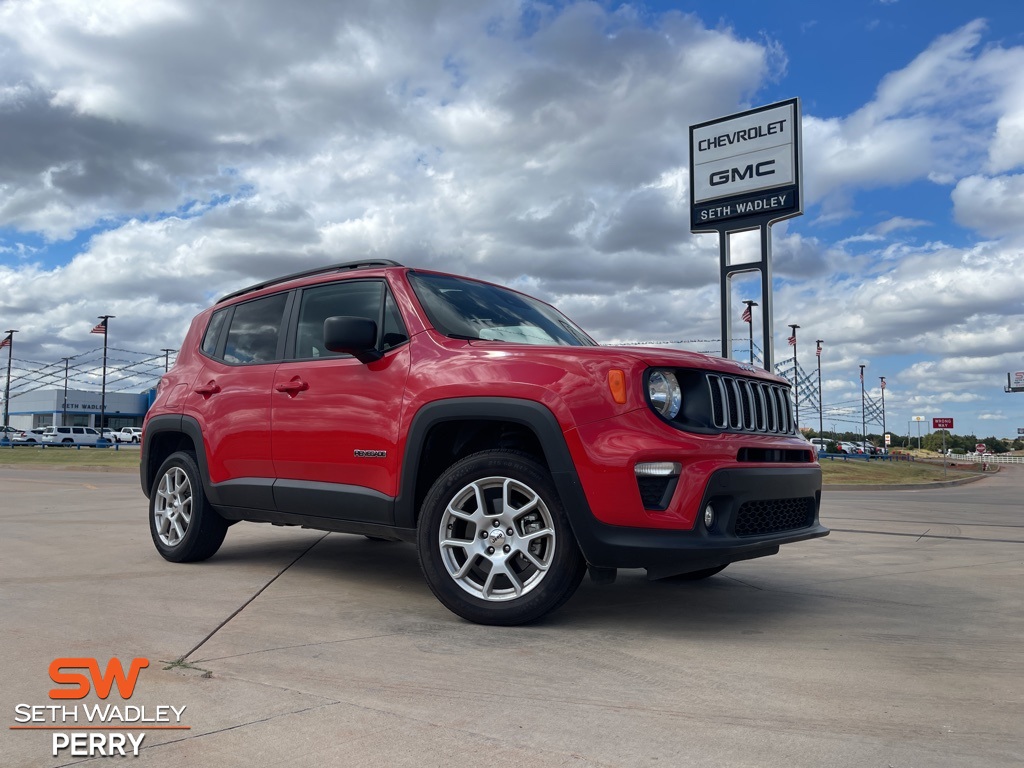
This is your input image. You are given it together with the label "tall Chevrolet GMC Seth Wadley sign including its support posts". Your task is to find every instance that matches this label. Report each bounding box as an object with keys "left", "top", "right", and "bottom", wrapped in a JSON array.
[{"left": 690, "top": 98, "right": 804, "bottom": 371}]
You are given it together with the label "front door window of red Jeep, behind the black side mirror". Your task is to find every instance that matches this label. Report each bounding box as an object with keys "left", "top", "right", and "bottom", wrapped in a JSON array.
[{"left": 295, "top": 280, "right": 407, "bottom": 359}]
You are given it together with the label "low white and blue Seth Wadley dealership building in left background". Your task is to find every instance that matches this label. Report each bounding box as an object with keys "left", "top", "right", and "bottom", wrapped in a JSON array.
[{"left": 8, "top": 389, "right": 155, "bottom": 430}]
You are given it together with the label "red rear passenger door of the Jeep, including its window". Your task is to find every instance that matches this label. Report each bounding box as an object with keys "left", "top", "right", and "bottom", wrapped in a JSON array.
[{"left": 183, "top": 292, "right": 290, "bottom": 509}]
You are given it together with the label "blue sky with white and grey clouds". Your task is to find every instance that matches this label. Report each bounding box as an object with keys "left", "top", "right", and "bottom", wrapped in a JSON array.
[{"left": 0, "top": 0, "right": 1024, "bottom": 437}]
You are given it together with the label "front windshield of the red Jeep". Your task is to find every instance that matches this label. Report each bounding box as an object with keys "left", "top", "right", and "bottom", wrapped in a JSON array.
[{"left": 409, "top": 272, "right": 596, "bottom": 347}]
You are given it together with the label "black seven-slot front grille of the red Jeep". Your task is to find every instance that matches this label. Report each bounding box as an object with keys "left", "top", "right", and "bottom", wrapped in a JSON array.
[{"left": 708, "top": 374, "right": 796, "bottom": 434}]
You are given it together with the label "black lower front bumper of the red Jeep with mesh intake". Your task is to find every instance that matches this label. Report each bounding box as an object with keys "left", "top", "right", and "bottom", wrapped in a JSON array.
[{"left": 567, "top": 466, "right": 829, "bottom": 578}]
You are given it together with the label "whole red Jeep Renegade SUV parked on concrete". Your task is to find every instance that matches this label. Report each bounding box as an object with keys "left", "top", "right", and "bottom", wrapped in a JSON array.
[{"left": 140, "top": 260, "right": 828, "bottom": 625}]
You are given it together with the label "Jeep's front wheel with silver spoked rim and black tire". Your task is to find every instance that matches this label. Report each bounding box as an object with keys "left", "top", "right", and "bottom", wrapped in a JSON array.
[{"left": 417, "top": 450, "right": 587, "bottom": 627}]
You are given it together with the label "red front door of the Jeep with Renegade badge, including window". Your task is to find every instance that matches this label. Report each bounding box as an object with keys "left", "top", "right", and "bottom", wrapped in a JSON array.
[{"left": 271, "top": 279, "right": 410, "bottom": 523}]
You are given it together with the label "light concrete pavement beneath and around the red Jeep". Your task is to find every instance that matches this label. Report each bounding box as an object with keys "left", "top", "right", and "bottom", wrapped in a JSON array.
[{"left": 0, "top": 469, "right": 1024, "bottom": 768}]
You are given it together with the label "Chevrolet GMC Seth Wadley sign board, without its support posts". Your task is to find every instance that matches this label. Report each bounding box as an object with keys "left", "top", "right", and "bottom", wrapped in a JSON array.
[{"left": 690, "top": 99, "right": 802, "bottom": 231}]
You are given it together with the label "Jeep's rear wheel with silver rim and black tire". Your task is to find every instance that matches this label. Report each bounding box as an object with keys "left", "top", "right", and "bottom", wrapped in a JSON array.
[{"left": 150, "top": 451, "right": 227, "bottom": 562}]
